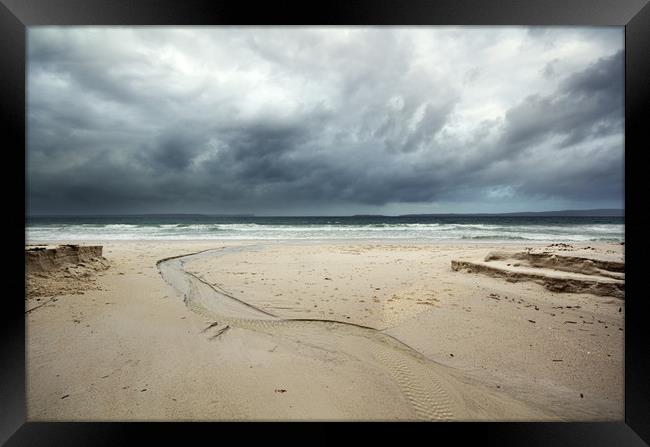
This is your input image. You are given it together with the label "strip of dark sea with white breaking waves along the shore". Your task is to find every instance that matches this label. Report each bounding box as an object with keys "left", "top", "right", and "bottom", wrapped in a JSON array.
[{"left": 25, "top": 215, "right": 625, "bottom": 242}]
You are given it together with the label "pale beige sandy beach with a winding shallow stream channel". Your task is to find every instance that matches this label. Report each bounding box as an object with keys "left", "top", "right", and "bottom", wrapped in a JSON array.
[{"left": 26, "top": 241, "right": 625, "bottom": 421}]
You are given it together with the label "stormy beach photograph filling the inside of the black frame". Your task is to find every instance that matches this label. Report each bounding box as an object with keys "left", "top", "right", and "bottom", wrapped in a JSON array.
[{"left": 25, "top": 26, "right": 625, "bottom": 422}]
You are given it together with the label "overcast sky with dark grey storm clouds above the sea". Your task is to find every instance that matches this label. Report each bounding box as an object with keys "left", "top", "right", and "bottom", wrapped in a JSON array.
[{"left": 27, "top": 27, "right": 624, "bottom": 215}]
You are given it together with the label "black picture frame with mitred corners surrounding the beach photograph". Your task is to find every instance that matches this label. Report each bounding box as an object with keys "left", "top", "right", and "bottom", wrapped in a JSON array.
[{"left": 0, "top": 0, "right": 650, "bottom": 446}]
